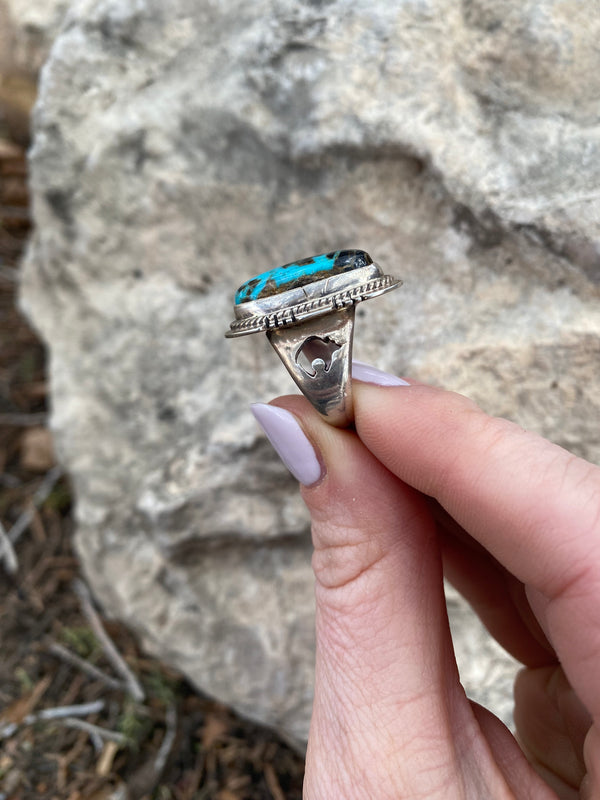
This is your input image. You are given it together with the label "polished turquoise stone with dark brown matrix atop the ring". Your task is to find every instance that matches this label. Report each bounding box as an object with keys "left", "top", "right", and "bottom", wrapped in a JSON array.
[{"left": 235, "top": 250, "right": 373, "bottom": 305}]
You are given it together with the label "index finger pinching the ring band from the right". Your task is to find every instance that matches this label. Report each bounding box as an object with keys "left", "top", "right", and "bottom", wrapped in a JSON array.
[{"left": 353, "top": 382, "right": 600, "bottom": 719}]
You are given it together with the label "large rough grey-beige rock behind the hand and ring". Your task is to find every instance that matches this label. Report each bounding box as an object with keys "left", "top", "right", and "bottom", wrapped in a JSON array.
[{"left": 23, "top": 0, "right": 600, "bottom": 752}]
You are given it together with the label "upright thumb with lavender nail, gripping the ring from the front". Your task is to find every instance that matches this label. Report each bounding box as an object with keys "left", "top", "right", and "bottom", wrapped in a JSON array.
[{"left": 254, "top": 397, "right": 508, "bottom": 800}]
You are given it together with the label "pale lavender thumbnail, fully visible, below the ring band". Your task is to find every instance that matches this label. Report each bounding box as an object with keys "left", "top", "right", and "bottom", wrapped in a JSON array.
[{"left": 251, "top": 403, "right": 323, "bottom": 486}]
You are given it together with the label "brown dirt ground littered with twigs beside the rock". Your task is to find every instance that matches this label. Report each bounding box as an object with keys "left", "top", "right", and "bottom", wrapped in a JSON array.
[{"left": 0, "top": 128, "right": 304, "bottom": 800}]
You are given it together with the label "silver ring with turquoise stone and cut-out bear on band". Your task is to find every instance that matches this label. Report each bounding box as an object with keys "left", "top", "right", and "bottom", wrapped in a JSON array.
[{"left": 225, "top": 250, "right": 402, "bottom": 427}]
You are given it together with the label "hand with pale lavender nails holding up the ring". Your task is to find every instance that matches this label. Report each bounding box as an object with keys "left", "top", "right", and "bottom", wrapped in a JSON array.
[{"left": 255, "top": 365, "right": 600, "bottom": 800}]
